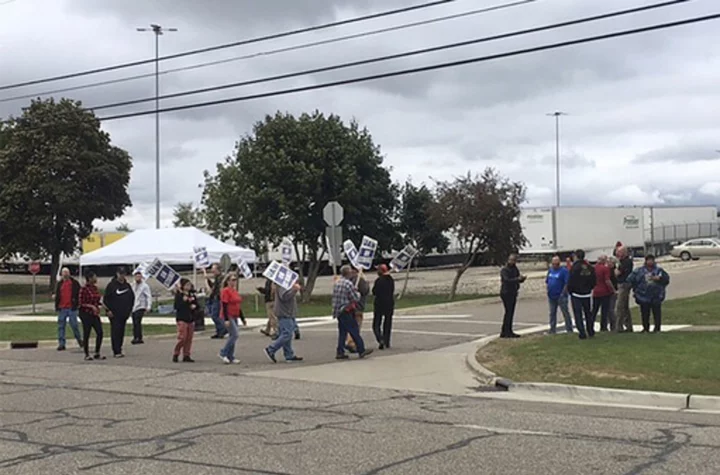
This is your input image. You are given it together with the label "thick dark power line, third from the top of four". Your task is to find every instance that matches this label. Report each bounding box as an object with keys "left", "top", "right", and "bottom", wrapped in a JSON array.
[{"left": 88, "top": 0, "right": 688, "bottom": 111}]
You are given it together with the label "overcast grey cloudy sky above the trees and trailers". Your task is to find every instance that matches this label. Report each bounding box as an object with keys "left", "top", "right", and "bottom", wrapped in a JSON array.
[{"left": 0, "top": 0, "right": 720, "bottom": 230}]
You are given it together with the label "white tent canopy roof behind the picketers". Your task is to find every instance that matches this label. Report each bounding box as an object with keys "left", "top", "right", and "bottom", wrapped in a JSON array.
[{"left": 80, "top": 228, "right": 255, "bottom": 266}]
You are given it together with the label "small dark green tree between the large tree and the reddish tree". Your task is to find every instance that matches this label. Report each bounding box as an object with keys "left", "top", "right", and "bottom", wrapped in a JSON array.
[{"left": 398, "top": 180, "right": 450, "bottom": 299}]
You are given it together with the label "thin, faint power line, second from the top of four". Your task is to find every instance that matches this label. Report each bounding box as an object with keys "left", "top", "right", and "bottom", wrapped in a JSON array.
[{"left": 0, "top": 0, "right": 537, "bottom": 103}]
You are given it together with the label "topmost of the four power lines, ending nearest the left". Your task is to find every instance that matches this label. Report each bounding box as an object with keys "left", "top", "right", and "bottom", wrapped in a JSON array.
[{"left": 0, "top": 0, "right": 457, "bottom": 91}]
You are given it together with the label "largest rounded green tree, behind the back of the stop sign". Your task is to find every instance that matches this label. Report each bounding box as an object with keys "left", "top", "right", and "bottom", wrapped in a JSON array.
[{"left": 202, "top": 112, "right": 399, "bottom": 300}]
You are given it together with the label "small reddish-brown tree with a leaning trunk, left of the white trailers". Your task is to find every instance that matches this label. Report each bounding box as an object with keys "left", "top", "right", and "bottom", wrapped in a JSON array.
[{"left": 433, "top": 168, "right": 526, "bottom": 300}]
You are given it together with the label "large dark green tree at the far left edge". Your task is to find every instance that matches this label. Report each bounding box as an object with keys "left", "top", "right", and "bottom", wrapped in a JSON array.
[{"left": 0, "top": 99, "right": 132, "bottom": 285}]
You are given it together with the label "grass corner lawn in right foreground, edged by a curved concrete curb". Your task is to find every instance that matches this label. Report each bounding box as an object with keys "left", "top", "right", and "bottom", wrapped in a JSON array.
[{"left": 477, "top": 332, "right": 720, "bottom": 395}]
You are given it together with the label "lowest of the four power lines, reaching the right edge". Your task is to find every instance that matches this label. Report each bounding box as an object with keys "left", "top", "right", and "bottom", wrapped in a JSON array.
[{"left": 99, "top": 13, "right": 720, "bottom": 121}]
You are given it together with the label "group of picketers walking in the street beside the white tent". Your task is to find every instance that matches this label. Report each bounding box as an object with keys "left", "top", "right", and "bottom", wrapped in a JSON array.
[{"left": 54, "top": 264, "right": 395, "bottom": 364}]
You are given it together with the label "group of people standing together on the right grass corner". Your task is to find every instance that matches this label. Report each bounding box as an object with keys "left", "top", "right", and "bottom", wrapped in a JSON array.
[{"left": 500, "top": 243, "right": 670, "bottom": 340}]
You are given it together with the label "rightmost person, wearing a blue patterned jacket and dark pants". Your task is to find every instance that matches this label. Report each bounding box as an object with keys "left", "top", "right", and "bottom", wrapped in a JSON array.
[{"left": 628, "top": 254, "right": 670, "bottom": 333}]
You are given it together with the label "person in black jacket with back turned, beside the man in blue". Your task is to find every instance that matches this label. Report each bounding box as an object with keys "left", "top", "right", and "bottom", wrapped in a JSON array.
[{"left": 568, "top": 249, "right": 596, "bottom": 340}]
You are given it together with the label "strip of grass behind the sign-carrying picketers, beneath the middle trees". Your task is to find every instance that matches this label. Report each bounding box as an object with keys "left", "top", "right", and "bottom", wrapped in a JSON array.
[{"left": 16, "top": 294, "right": 493, "bottom": 318}]
